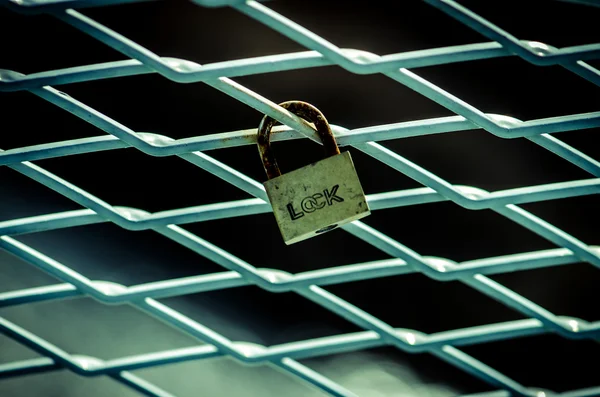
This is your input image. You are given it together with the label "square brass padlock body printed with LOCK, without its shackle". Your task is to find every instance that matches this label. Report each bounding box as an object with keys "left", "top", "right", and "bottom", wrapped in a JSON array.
[{"left": 264, "top": 152, "right": 371, "bottom": 245}]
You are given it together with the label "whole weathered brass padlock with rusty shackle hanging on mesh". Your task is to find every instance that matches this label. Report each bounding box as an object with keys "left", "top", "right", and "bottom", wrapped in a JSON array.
[{"left": 257, "top": 101, "right": 371, "bottom": 245}]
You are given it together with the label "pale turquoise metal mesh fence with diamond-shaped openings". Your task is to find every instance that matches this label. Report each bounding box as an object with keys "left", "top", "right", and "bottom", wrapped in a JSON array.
[{"left": 0, "top": 0, "right": 600, "bottom": 396}]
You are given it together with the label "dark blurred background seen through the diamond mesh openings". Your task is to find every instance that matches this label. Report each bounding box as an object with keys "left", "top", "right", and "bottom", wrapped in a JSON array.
[{"left": 0, "top": 0, "right": 600, "bottom": 397}]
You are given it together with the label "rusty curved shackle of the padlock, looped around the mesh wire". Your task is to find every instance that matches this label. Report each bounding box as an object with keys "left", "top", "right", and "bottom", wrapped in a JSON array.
[{"left": 256, "top": 101, "right": 340, "bottom": 179}]
